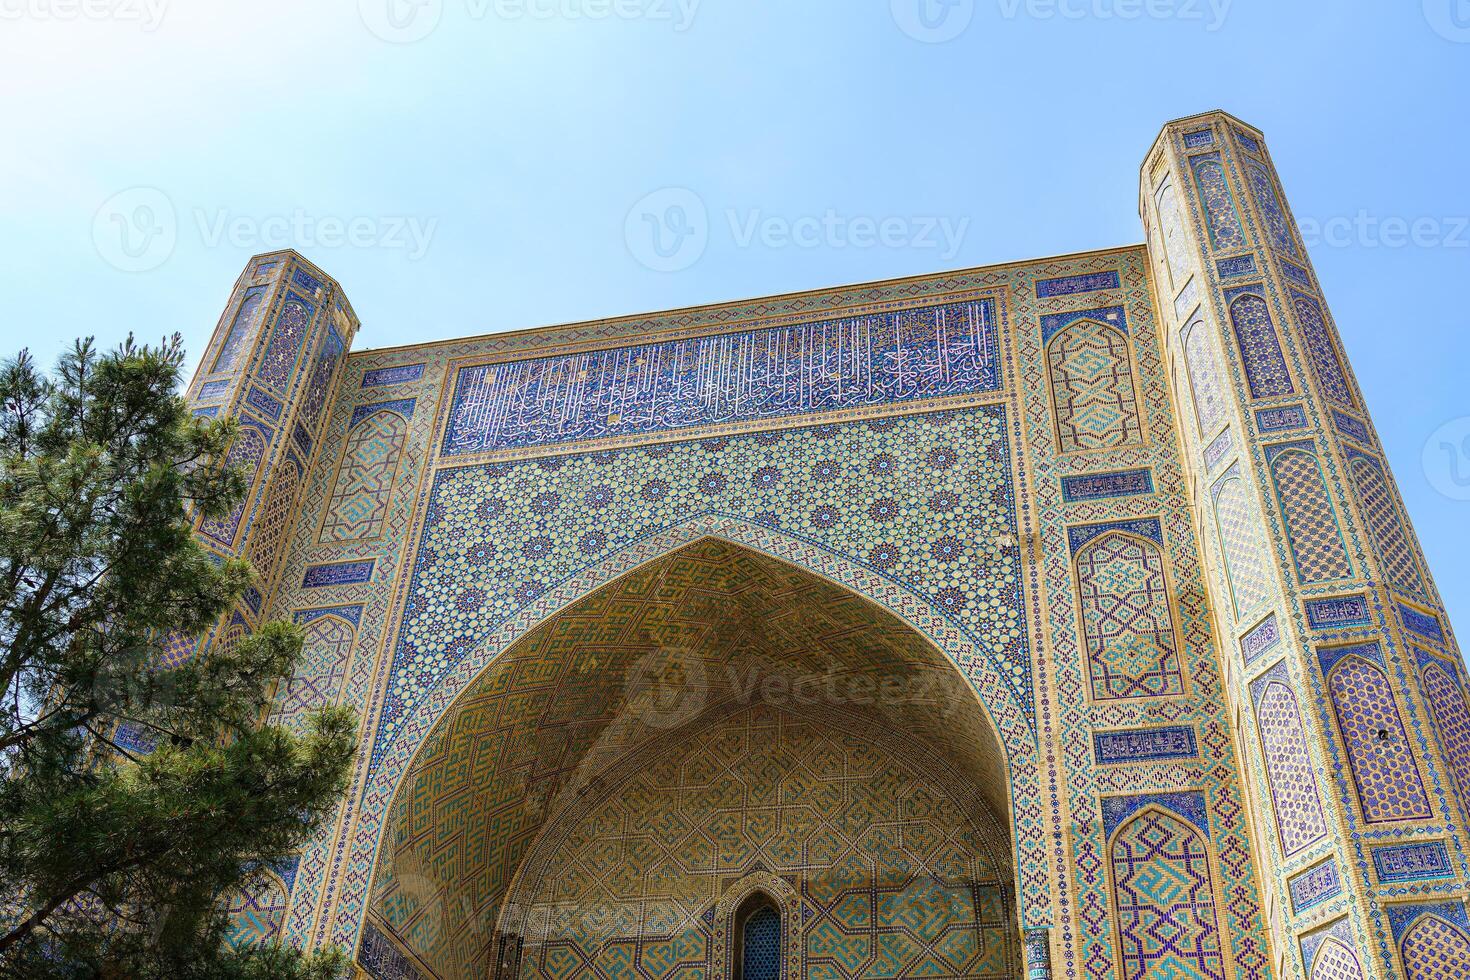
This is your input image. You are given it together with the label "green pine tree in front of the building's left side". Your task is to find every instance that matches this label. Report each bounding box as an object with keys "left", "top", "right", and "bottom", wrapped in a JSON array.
[{"left": 0, "top": 336, "right": 356, "bottom": 980}]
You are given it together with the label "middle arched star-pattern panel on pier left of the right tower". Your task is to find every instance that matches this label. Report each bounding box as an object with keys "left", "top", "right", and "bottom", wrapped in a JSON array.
[{"left": 1076, "top": 532, "right": 1183, "bottom": 699}]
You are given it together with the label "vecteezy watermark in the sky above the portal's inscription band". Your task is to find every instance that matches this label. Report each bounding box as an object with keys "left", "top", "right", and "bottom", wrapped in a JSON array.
[{"left": 623, "top": 187, "right": 970, "bottom": 272}]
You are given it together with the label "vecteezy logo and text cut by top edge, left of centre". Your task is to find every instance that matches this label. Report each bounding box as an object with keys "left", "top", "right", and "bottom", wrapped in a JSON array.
[{"left": 358, "top": 0, "right": 701, "bottom": 44}]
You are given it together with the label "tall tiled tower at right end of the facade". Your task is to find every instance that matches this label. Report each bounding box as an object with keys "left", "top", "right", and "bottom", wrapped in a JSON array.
[{"left": 1139, "top": 112, "right": 1470, "bottom": 980}]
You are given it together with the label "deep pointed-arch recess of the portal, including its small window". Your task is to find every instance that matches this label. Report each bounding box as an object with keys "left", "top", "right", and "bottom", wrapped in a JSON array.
[{"left": 361, "top": 538, "right": 1020, "bottom": 979}]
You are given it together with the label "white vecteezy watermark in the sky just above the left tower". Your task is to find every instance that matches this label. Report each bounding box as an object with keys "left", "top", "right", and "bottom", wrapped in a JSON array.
[{"left": 93, "top": 187, "right": 438, "bottom": 272}]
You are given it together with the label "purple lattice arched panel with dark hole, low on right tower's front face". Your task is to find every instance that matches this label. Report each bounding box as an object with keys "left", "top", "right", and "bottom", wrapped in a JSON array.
[{"left": 1327, "top": 654, "right": 1432, "bottom": 823}]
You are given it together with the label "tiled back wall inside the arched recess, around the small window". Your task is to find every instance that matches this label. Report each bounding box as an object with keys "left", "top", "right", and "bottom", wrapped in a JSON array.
[{"left": 503, "top": 705, "right": 1019, "bottom": 980}]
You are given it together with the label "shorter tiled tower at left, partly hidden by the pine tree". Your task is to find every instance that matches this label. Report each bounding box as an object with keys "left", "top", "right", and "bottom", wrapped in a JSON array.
[{"left": 182, "top": 251, "right": 359, "bottom": 663}]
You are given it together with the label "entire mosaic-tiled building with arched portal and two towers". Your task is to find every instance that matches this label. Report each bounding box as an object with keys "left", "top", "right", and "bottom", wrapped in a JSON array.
[{"left": 166, "top": 113, "right": 1470, "bottom": 980}]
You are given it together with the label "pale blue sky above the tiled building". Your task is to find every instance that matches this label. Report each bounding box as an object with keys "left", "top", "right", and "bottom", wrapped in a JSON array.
[{"left": 0, "top": 0, "right": 1470, "bottom": 623}]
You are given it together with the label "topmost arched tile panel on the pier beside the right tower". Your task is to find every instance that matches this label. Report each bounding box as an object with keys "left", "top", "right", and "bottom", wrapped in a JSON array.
[{"left": 1047, "top": 320, "right": 1142, "bottom": 453}]
